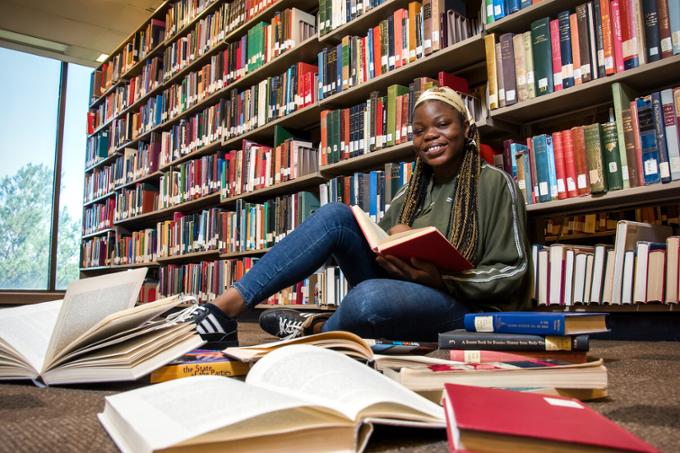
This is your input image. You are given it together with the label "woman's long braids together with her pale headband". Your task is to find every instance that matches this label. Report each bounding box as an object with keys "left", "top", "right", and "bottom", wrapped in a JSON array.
[{"left": 399, "top": 87, "right": 482, "bottom": 264}]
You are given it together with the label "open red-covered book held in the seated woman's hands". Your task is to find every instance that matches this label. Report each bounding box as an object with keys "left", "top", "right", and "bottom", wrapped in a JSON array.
[{"left": 352, "top": 205, "right": 473, "bottom": 272}]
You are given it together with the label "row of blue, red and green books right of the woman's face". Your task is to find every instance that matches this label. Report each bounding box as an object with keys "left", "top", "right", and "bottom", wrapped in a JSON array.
[{"left": 503, "top": 83, "right": 680, "bottom": 203}]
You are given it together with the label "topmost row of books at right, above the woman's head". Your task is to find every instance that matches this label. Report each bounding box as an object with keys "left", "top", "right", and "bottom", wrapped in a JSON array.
[{"left": 484, "top": 0, "right": 680, "bottom": 109}]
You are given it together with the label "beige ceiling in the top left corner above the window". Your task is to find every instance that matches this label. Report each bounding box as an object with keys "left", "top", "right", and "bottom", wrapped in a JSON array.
[{"left": 0, "top": 0, "right": 163, "bottom": 66}]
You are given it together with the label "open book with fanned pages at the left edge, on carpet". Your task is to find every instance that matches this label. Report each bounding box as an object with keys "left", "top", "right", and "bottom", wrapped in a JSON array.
[{"left": 0, "top": 268, "right": 204, "bottom": 385}]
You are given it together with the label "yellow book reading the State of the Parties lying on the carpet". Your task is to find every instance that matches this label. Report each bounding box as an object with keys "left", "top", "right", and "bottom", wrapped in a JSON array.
[{"left": 151, "top": 349, "right": 249, "bottom": 384}]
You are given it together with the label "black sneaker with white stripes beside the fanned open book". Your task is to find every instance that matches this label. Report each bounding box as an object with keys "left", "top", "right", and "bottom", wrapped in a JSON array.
[{"left": 167, "top": 303, "right": 238, "bottom": 349}]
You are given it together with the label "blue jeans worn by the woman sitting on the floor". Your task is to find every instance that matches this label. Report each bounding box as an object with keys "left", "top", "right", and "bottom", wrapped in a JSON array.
[{"left": 234, "top": 203, "right": 470, "bottom": 341}]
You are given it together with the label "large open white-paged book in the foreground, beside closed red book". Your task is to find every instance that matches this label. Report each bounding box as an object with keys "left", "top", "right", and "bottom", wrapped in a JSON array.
[{"left": 99, "top": 345, "right": 445, "bottom": 453}]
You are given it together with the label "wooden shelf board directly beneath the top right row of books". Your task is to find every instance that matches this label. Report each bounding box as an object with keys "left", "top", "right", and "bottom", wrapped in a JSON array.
[{"left": 489, "top": 55, "right": 680, "bottom": 125}]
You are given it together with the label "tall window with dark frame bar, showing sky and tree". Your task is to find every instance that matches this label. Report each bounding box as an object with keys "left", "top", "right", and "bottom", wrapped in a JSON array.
[{"left": 0, "top": 48, "right": 91, "bottom": 291}]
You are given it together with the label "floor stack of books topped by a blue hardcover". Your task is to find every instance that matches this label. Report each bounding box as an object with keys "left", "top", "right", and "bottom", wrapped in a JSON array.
[{"left": 384, "top": 312, "right": 607, "bottom": 400}]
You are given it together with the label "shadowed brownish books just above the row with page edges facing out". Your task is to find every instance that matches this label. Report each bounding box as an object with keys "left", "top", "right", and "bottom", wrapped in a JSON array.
[{"left": 543, "top": 205, "right": 680, "bottom": 240}]
